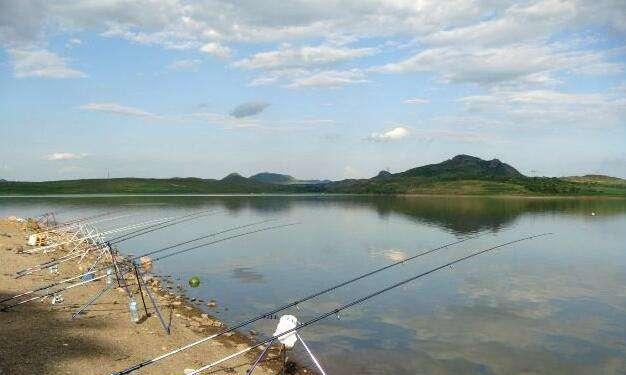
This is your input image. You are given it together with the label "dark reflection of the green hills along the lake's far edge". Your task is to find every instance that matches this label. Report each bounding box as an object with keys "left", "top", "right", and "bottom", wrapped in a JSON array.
[{"left": 0, "top": 195, "right": 626, "bottom": 235}]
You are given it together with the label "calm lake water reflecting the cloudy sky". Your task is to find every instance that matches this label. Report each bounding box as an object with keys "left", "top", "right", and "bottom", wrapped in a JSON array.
[{"left": 0, "top": 196, "right": 626, "bottom": 375}]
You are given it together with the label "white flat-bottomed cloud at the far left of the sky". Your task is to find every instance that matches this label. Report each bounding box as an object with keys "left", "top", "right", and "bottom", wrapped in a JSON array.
[{"left": 8, "top": 48, "right": 86, "bottom": 78}]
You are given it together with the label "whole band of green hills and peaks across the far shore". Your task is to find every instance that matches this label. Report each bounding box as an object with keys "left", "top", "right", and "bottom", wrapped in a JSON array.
[{"left": 0, "top": 155, "right": 626, "bottom": 196}]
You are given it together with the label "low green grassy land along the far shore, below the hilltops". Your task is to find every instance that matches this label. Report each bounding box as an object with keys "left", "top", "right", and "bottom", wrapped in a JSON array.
[{"left": 0, "top": 176, "right": 626, "bottom": 197}]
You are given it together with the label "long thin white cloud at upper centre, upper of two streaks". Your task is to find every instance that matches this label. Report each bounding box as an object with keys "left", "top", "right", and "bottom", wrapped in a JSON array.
[{"left": 233, "top": 45, "right": 377, "bottom": 69}]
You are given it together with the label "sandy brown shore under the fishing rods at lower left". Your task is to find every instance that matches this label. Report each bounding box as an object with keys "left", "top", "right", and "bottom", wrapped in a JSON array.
[{"left": 0, "top": 219, "right": 304, "bottom": 375}]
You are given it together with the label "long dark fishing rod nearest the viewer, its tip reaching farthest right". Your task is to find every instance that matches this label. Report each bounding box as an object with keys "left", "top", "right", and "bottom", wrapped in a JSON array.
[{"left": 182, "top": 233, "right": 553, "bottom": 375}]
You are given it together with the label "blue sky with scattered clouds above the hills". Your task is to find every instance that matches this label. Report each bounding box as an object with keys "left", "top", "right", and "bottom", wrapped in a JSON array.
[{"left": 0, "top": 0, "right": 626, "bottom": 181}]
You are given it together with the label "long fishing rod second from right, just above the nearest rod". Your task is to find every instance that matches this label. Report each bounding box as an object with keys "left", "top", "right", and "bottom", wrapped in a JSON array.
[{"left": 115, "top": 235, "right": 482, "bottom": 375}]
